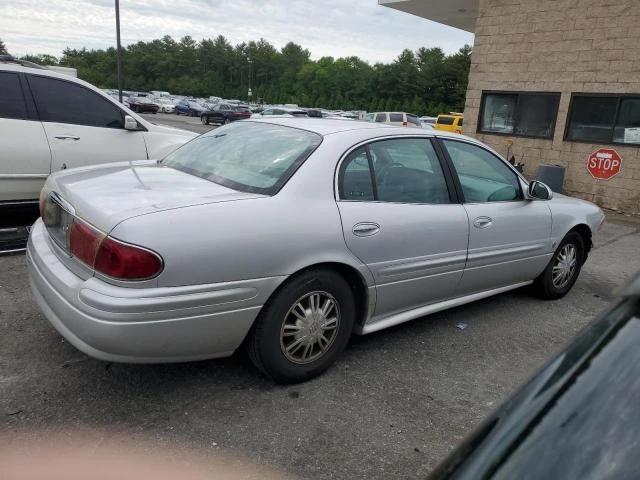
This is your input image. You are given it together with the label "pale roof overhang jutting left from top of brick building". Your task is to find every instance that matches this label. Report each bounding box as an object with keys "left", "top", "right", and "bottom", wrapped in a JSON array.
[{"left": 378, "top": 0, "right": 480, "bottom": 33}]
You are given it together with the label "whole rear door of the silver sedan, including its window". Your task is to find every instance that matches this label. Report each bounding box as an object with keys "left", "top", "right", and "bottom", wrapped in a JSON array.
[{"left": 338, "top": 138, "right": 469, "bottom": 321}]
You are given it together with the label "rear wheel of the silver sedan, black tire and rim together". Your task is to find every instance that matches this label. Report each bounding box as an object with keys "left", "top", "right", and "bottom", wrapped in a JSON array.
[{"left": 246, "top": 269, "right": 355, "bottom": 384}]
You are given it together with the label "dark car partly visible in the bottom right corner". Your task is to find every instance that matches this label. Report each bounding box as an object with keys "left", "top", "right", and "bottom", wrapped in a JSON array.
[{"left": 429, "top": 277, "right": 640, "bottom": 480}]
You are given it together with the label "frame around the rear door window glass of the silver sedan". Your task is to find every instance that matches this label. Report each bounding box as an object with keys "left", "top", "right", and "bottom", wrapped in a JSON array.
[{"left": 334, "top": 135, "right": 463, "bottom": 205}]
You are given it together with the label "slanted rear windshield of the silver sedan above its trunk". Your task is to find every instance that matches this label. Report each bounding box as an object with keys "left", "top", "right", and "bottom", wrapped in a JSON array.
[{"left": 162, "top": 122, "right": 322, "bottom": 195}]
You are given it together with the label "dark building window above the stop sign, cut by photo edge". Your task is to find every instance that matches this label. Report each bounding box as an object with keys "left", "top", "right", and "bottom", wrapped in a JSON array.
[{"left": 565, "top": 93, "right": 640, "bottom": 145}]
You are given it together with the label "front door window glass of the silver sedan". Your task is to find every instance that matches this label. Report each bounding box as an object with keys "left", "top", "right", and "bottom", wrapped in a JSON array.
[{"left": 442, "top": 140, "right": 523, "bottom": 203}]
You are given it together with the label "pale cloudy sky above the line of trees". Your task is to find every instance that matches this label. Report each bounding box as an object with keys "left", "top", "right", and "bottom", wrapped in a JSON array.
[{"left": 0, "top": 0, "right": 473, "bottom": 63}]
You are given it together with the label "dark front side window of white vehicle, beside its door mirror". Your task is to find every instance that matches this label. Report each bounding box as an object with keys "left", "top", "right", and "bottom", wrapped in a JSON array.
[{"left": 29, "top": 75, "right": 124, "bottom": 128}]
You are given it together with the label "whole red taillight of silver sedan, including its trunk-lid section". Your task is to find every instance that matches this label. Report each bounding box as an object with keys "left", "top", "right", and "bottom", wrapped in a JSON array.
[{"left": 68, "top": 220, "right": 162, "bottom": 280}]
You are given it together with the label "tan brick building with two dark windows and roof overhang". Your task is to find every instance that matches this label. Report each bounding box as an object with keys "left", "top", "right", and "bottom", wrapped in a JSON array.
[{"left": 379, "top": 0, "right": 640, "bottom": 214}]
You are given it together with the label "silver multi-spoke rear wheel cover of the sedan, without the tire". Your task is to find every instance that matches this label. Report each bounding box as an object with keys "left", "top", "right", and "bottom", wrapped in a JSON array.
[{"left": 280, "top": 291, "right": 340, "bottom": 364}]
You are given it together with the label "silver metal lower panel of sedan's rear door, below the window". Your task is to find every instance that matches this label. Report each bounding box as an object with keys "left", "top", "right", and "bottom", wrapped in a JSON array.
[{"left": 338, "top": 202, "right": 469, "bottom": 316}]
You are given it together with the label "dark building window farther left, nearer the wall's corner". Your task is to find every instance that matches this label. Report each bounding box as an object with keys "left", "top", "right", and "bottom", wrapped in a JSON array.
[{"left": 478, "top": 92, "right": 560, "bottom": 138}]
